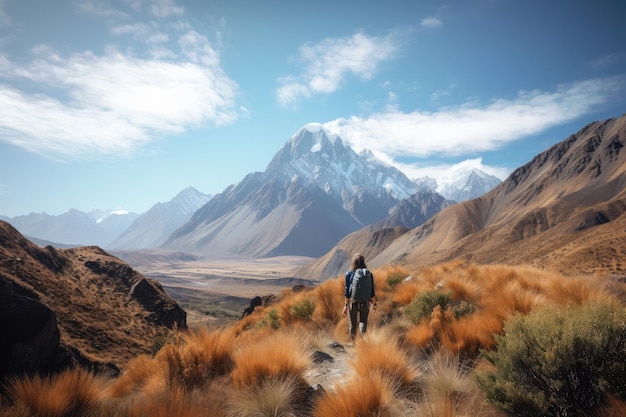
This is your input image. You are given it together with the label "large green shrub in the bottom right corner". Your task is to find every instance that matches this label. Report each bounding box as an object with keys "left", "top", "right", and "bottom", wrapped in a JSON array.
[{"left": 477, "top": 301, "right": 626, "bottom": 417}]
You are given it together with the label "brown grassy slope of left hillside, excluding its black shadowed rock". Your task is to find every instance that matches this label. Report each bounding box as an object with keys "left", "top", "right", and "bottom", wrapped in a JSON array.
[{"left": 0, "top": 222, "right": 186, "bottom": 374}]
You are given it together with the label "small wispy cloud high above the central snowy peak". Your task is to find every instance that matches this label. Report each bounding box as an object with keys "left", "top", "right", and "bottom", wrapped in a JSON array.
[{"left": 276, "top": 33, "right": 400, "bottom": 107}]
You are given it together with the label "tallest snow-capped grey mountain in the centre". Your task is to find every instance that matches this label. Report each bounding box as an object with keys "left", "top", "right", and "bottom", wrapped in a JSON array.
[{"left": 162, "top": 124, "right": 426, "bottom": 257}]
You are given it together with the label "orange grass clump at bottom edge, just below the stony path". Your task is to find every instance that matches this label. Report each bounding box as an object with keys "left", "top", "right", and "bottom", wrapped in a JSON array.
[{"left": 313, "top": 373, "right": 396, "bottom": 417}]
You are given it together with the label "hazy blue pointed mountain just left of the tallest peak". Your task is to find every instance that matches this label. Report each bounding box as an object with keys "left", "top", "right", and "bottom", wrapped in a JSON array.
[{"left": 106, "top": 187, "right": 211, "bottom": 250}]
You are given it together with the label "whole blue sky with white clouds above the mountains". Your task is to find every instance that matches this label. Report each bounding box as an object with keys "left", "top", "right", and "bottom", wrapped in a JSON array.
[{"left": 0, "top": 0, "right": 626, "bottom": 217}]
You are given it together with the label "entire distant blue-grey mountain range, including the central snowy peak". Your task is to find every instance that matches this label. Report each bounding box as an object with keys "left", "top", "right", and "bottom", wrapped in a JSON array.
[{"left": 0, "top": 124, "right": 500, "bottom": 257}]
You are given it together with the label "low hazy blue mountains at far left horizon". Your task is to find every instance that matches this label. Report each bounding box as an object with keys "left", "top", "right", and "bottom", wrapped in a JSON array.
[{"left": 7, "top": 209, "right": 139, "bottom": 247}]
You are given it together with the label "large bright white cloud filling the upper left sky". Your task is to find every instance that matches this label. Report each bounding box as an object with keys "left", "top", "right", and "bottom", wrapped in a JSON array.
[{"left": 0, "top": 40, "right": 242, "bottom": 158}]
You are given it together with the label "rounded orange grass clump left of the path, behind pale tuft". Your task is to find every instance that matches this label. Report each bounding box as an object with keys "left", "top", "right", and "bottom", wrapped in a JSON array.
[{"left": 231, "top": 332, "right": 309, "bottom": 388}]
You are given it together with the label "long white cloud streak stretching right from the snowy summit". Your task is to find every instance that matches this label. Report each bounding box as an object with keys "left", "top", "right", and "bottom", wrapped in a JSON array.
[{"left": 324, "top": 78, "right": 624, "bottom": 161}]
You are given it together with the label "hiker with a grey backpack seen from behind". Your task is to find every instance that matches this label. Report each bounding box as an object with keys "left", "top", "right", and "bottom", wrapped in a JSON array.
[{"left": 343, "top": 253, "right": 376, "bottom": 340}]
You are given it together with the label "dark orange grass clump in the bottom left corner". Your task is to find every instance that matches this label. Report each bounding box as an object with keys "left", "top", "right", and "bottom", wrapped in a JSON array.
[{"left": 8, "top": 369, "right": 105, "bottom": 417}]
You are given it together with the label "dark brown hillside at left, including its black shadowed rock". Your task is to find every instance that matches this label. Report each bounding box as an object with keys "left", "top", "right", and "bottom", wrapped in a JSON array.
[{"left": 0, "top": 221, "right": 186, "bottom": 380}]
